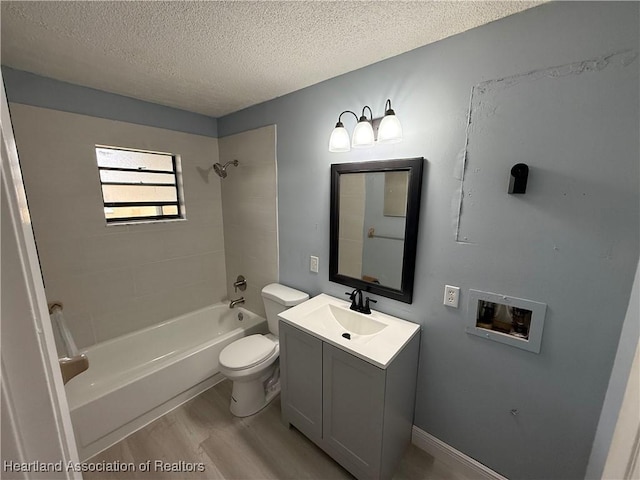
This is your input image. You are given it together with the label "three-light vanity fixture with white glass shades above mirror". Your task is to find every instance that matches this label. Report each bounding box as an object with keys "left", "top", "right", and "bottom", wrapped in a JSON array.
[{"left": 329, "top": 100, "right": 402, "bottom": 152}]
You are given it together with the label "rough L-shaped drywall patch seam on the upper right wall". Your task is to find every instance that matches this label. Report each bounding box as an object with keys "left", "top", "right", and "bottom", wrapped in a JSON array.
[{"left": 452, "top": 49, "right": 638, "bottom": 244}]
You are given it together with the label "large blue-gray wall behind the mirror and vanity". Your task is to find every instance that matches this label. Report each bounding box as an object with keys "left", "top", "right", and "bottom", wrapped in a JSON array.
[{"left": 218, "top": 2, "right": 640, "bottom": 479}]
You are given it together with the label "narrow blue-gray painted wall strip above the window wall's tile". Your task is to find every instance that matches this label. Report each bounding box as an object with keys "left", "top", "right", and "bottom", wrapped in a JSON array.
[{"left": 2, "top": 65, "right": 218, "bottom": 137}]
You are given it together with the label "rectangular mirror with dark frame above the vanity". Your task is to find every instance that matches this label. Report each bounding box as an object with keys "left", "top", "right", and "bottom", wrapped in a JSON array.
[{"left": 329, "top": 157, "right": 424, "bottom": 303}]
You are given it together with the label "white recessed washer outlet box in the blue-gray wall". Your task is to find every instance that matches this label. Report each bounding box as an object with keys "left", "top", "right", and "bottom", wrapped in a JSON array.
[{"left": 466, "top": 290, "right": 547, "bottom": 353}]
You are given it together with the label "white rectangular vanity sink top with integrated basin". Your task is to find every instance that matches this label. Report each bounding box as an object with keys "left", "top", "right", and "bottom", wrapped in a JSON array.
[{"left": 279, "top": 293, "right": 420, "bottom": 368}]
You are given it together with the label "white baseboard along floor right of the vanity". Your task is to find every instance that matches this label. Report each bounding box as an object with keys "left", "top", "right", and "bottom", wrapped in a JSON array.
[{"left": 411, "top": 425, "right": 508, "bottom": 480}]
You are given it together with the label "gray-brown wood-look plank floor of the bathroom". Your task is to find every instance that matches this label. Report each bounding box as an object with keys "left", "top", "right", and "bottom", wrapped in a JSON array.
[{"left": 83, "top": 380, "right": 464, "bottom": 480}]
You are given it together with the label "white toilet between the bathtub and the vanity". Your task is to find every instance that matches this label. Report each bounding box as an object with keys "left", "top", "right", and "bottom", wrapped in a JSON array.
[{"left": 219, "top": 283, "right": 309, "bottom": 417}]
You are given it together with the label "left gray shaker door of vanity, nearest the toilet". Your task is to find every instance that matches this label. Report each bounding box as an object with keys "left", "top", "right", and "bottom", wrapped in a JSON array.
[{"left": 279, "top": 322, "right": 322, "bottom": 443}]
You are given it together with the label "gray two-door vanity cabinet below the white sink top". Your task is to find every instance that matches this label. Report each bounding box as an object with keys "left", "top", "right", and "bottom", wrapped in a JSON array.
[{"left": 280, "top": 322, "right": 420, "bottom": 479}]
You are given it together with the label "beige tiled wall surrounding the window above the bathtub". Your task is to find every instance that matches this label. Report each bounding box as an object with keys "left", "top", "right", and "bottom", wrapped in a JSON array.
[{"left": 10, "top": 103, "right": 227, "bottom": 347}]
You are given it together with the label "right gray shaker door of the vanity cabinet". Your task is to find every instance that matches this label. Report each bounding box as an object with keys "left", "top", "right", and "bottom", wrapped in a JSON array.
[{"left": 322, "top": 343, "right": 385, "bottom": 478}]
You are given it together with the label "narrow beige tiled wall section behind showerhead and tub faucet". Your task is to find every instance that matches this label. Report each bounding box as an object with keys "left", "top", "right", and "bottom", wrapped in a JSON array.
[{"left": 218, "top": 125, "right": 278, "bottom": 316}]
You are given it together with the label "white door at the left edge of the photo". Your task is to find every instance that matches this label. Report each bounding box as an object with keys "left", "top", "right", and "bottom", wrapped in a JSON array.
[{"left": 0, "top": 73, "right": 82, "bottom": 479}]
